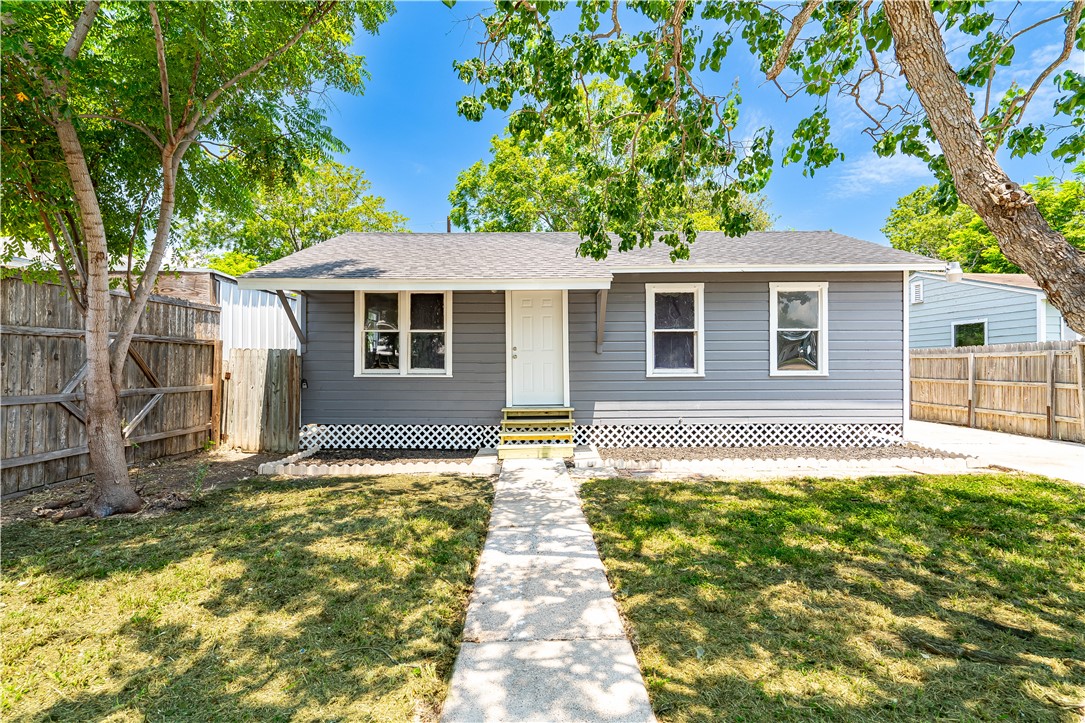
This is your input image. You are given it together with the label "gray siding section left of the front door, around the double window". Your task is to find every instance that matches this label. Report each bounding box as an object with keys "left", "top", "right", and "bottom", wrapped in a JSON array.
[{"left": 302, "top": 291, "right": 505, "bottom": 424}]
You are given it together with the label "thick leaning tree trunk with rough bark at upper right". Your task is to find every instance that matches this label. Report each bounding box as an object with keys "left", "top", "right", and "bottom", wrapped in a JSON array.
[{"left": 885, "top": 0, "right": 1085, "bottom": 333}]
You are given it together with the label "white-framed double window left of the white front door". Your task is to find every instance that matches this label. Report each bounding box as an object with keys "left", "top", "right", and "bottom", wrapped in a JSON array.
[{"left": 354, "top": 291, "right": 452, "bottom": 377}]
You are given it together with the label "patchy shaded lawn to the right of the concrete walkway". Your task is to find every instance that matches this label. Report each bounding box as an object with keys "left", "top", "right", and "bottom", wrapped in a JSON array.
[{"left": 582, "top": 474, "right": 1085, "bottom": 721}]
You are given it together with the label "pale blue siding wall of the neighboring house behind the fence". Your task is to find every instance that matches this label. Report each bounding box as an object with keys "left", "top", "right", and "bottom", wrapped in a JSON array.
[{"left": 908, "top": 277, "right": 1038, "bottom": 348}]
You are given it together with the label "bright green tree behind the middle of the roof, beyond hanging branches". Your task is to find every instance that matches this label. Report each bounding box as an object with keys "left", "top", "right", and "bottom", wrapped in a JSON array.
[{"left": 448, "top": 81, "right": 773, "bottom": 231}]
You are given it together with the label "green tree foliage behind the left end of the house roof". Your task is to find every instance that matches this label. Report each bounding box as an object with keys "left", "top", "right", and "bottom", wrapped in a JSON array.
[{"left": 178, "top": 161, "right": 407, "bottom": 265}]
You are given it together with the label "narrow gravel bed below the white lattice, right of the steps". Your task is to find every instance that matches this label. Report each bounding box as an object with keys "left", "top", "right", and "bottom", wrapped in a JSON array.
[{"left": 599, "top": 444, "right": 963, "bottom": 461}]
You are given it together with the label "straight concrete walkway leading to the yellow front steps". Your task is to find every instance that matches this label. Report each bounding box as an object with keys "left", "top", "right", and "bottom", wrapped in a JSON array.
[{"left": 441, "top": 459, "right": 655, "bottom": 723}]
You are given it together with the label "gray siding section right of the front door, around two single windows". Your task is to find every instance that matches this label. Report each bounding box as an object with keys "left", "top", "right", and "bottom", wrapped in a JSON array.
[{"left": 569, "top": 274, "right": 904, "bottom": 424}]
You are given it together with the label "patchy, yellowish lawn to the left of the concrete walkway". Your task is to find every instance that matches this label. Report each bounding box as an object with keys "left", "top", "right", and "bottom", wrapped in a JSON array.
[{"left": 0, "top": 477, "right": 493, "bottom": 721}]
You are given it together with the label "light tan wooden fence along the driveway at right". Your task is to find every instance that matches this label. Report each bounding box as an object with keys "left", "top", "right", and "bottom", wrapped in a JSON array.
[{"left": 911, "top": 342, "right": 1085, "bottom": 442}]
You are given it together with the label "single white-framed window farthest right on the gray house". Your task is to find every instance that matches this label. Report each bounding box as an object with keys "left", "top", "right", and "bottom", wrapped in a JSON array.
[{"left": 768, "top": 282, "right": 829, "bottom": 376}]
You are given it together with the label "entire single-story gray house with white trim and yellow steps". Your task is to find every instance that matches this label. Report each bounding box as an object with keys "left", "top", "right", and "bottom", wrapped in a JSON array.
[{"left": 240, "top": 231, "right": 945, "bottom": 455}]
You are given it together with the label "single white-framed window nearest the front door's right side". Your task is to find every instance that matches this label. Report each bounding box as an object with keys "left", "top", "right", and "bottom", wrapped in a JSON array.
[{"left": 644, "top": 283, "right": 704, "bottom": 377}]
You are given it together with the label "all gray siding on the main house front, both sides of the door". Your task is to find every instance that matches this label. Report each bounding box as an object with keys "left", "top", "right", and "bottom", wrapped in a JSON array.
[{"left": 302, "top": 274, "right": 903, "bottom": 424}]
